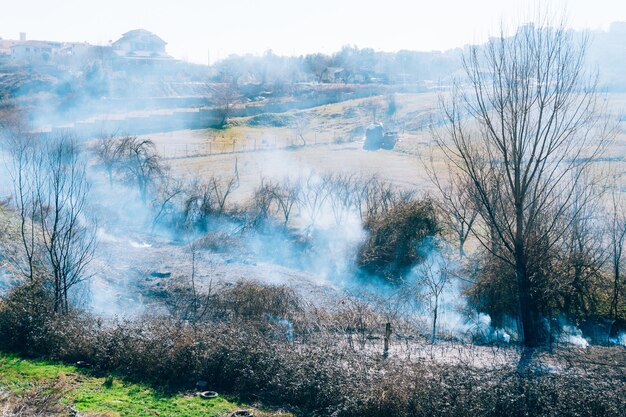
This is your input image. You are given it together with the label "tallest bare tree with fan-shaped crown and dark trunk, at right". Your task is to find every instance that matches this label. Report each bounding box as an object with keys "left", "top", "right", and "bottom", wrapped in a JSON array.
[{"left": 437, "top": 21, "right": 604, "bottom": 346}]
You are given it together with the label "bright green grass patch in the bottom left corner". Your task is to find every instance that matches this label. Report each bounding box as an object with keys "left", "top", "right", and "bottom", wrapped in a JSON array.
[{"left": 0, "top": 354, "right": 280, "bottom": 417}]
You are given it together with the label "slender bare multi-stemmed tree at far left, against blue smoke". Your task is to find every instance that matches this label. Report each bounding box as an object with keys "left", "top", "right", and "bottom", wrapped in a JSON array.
[{"left": 5, "top": 130, "right": 96, "bottom": 313}]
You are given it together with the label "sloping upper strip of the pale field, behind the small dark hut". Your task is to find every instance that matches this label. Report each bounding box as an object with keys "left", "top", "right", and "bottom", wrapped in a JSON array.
[{"left": 145, "top": 93, "right": 437, "bottom": 158}]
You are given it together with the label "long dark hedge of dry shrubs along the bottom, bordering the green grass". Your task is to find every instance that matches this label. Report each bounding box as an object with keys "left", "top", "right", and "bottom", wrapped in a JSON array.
[{"left": 0, "top": 283, "right": 626, "bottom": 417}]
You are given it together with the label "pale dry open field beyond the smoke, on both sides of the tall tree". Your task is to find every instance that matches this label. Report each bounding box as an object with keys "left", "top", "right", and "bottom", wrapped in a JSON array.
[{"left": 133, "top": 93, "right": 626, "bottom": 208}]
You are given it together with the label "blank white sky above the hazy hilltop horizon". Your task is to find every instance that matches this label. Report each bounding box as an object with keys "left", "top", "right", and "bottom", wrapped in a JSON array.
[{"left": 0, "top": 0, "right": 626, "bottom": 63}]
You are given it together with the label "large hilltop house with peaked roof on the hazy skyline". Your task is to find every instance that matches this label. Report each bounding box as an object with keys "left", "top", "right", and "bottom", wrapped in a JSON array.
[{"left": 111, "top": 29, "right": 172, "bottom": 61}]
